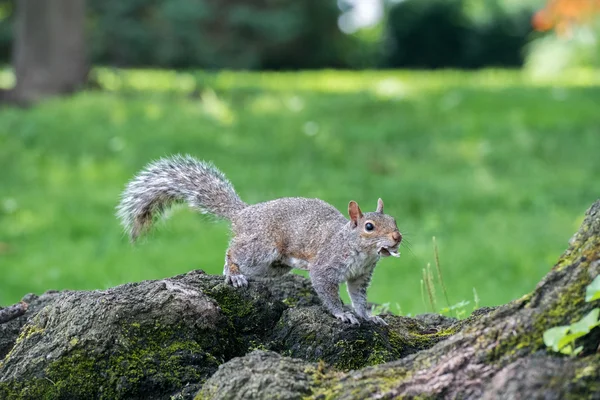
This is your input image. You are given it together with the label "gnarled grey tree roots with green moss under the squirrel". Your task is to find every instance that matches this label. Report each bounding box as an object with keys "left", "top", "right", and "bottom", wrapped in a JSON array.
[{"left": 0, "top": 201, "right": 600, "bottom": 399}]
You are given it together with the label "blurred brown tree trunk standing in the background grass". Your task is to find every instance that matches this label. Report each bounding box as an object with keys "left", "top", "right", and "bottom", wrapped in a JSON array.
[{"left": 5, "top": 0, "right": 88, "bottom": 104}]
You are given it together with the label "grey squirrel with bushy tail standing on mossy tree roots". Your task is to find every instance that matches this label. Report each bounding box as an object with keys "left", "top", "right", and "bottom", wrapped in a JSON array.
[{"left": 117, "top": 156, "right": 402, "bottom": 325}]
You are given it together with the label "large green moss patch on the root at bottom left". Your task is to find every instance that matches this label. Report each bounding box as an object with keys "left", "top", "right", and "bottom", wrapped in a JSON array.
[{"left": 0, "top": 323, "right": 226, "bottom": 400}]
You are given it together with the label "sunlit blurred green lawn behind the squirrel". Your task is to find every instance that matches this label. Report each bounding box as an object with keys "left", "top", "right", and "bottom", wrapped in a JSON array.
[{"left": 0, "top": 69, "right": 600, "bottom": 313}]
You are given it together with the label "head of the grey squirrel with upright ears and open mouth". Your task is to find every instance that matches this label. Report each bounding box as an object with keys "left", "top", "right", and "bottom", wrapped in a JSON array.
[{"left": 348, "top": 199, "right": 402, "bottom": 257}]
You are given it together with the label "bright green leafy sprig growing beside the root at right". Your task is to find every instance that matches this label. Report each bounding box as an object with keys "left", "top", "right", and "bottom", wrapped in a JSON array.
[{"left": 544, "top": 275, "right": 600, "bottom": 356}]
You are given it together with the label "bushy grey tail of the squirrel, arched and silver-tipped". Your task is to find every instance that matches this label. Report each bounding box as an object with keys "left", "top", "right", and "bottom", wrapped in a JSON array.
[{"left": 117, "top": 155, "right": 246, "bottom": 241}]
